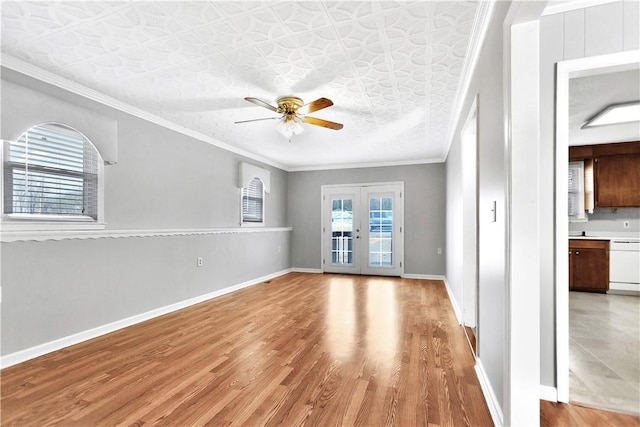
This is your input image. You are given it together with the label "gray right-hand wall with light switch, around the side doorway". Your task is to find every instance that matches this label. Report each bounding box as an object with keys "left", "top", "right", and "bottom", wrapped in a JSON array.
[{"left": 446, "top": 2, "right": 509, "bottom": 412}]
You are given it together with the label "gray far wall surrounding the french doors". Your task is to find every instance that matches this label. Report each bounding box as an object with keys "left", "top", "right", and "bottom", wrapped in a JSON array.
[{"left": 287, "top": 163, "right": 446, "bottom": 275}]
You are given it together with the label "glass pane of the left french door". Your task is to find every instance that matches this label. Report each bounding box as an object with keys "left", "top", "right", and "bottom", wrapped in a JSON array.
[{"left": 331, "top": 199, "right": 353, "bottom": 265}]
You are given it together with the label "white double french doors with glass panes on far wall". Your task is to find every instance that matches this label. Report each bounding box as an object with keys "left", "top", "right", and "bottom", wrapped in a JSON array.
[{"left": 322, "top": 183, "right": 404, "bottom": 276}]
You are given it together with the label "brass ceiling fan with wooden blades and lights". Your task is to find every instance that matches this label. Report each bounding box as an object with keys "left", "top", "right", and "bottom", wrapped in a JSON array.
[{"left": 235, "top": 96, "right": 343, "bottom": 140}]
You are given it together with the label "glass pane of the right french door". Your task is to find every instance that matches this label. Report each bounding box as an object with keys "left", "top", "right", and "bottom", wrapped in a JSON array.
[{"left": 369, "top": 197, "right": 393, "bottom": 267}]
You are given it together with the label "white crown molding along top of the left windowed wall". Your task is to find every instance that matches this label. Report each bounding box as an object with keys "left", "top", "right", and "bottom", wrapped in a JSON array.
[{"left": 0, "top": 53, "right": 288, "bottom": 171}]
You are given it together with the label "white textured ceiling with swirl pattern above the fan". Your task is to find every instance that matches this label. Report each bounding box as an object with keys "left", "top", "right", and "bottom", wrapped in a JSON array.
[{"left": 1, "top": 1, "right": 478, "bottom": 170}]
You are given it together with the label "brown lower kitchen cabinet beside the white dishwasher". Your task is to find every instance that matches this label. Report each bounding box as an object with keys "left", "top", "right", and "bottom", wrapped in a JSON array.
[{"left": 569, "top": 239, "right": 609, "bottom": 293}]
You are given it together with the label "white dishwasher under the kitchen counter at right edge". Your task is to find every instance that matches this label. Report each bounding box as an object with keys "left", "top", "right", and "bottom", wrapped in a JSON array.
[{"left": 609, "top": 239, "right": 640, "bottom": 295}]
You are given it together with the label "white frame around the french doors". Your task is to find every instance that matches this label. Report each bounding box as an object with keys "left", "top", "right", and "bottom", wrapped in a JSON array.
[{"left": 320, "top": 181, "right": 404, "bottom": 276}]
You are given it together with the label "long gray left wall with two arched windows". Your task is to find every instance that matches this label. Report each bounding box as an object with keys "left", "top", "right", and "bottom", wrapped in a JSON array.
[{"left": 1, "top": 69, "right": 291, "bottom": 356}]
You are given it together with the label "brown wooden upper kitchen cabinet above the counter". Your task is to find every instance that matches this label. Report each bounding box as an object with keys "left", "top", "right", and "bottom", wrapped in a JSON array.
[{"left": 569, "top": 141, "right": 640, "bottom": 208}]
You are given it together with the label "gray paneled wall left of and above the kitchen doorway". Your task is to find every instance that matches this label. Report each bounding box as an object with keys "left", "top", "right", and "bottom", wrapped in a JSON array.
[{"left": 540, "top": 1, "right": 640, "bottom": 387}]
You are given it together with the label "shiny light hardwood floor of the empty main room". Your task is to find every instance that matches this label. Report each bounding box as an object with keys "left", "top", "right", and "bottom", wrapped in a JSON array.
[{"left": 2, "top": 273, "right": 492, "bottom": 426}]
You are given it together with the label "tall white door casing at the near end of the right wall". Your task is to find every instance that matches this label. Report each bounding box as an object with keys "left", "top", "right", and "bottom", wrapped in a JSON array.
[{"left": 504, "top": 2, "right": 545, "bottom": 425}]
